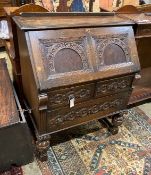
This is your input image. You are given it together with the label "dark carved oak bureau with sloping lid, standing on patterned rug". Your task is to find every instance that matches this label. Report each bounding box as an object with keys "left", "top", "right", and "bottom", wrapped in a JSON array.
[{"left": 13, "top": 13, "right": 140, "bottom": 159}]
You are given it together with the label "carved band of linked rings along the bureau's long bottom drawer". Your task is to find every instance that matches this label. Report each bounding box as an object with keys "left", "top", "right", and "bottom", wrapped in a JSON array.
[{"left": 48, "top": 98, "right": 125, "bottom": 126}]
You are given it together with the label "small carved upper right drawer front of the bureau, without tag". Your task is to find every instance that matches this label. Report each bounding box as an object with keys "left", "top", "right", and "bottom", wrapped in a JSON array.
[{"left": 95, "top": 75, "right": 134, "bottom": 97}]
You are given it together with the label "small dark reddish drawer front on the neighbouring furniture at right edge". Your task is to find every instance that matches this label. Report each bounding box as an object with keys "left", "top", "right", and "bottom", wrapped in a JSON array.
[{"left": 137, "top": 25, "right": 151, "bottom": 36}]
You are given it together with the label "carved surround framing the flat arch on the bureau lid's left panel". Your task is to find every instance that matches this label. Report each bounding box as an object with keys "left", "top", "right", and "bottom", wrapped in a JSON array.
[{"left": 39, "top": 37, "right": 89, "bottom": 75}]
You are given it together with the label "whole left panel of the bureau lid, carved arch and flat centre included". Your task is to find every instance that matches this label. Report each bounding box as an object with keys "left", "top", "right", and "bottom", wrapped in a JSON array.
[{"left": 39, "top": 37, "right": 89, "bottom": 75}]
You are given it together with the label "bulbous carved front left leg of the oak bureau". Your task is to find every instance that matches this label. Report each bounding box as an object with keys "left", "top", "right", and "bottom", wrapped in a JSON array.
[{"left": 36, "top": 140, "right": 50, "bottom": 161}]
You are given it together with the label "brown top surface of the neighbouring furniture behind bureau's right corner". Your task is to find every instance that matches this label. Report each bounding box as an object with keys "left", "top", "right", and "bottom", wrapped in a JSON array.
[{"left": 119, "top": 13, "right": 151, "bottom": 25}]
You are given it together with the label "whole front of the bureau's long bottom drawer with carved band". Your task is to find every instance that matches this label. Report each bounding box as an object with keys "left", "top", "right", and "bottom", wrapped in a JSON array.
[{"left": 47, "top": 91, "right": 130, "bottom": 132}]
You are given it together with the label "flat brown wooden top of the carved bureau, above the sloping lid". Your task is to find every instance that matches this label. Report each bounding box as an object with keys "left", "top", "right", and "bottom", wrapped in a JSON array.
[{"left": 13, "top": 13, "right": 133, "bottom": 30}]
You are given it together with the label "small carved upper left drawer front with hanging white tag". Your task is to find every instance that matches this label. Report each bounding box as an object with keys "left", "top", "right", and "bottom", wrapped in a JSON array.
[{"left": 48, "top": 83, "right": 95, "bottom": 108}]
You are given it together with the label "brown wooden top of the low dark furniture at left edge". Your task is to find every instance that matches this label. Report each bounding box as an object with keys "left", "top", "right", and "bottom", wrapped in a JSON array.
[{"left": 0, "top": 59, "right": 19, "bottom": 127}]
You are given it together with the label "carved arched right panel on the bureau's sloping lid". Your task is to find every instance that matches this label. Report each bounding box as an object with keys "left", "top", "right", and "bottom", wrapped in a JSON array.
[{"left": 93, "top": 33, "right": 130, "bottom": 67}]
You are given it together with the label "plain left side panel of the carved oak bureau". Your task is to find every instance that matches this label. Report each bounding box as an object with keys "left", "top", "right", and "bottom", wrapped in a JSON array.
[{"left": 17, "top": 29, "right": 46, "bottom": 133}]
